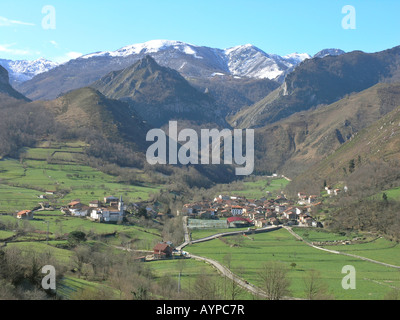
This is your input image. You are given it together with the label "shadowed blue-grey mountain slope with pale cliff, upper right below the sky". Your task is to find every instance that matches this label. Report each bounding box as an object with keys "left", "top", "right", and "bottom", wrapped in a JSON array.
[{"left": 229, "top": 46, "right": 400, "bottom": 128}]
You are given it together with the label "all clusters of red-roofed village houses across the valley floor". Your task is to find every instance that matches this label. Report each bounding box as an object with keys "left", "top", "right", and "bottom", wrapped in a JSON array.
[{"left": 12, "top": 182, "right": 347, "bottom": 261}]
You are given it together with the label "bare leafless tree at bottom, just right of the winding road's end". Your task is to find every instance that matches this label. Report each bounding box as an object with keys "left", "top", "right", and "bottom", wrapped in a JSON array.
[{"left": 259, "top": 261, "right": 290, "bottom": 300}]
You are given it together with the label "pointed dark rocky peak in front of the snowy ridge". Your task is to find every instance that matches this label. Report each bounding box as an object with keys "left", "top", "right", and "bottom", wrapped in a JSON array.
[{"left": 91, "top": 56, "right": 226, "bottom": 127}]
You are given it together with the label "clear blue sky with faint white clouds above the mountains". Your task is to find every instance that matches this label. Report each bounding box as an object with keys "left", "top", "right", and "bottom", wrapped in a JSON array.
[{"left": 0, "top": 0, "right": 400, "bottom": 61}]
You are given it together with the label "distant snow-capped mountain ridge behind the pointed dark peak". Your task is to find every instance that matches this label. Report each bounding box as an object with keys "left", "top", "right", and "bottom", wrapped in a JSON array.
[{"left": 15, "top": 40, "right": 316, "bottom": 100}]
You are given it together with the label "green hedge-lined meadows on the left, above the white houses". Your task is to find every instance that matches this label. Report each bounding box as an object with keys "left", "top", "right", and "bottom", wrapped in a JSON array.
[{"left": 0, "top": 142, "right": 160, "bottom": 213}]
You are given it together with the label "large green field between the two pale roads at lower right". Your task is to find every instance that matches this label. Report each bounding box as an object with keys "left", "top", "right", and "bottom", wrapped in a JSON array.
[{"left": 185, "top": 229, "right": 400, "bottom": 300}]
